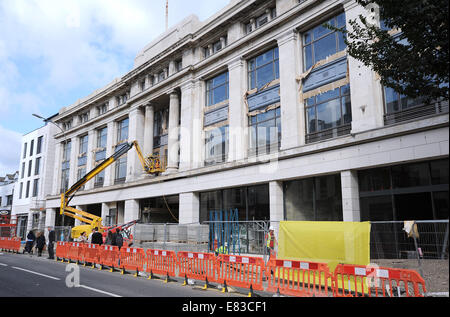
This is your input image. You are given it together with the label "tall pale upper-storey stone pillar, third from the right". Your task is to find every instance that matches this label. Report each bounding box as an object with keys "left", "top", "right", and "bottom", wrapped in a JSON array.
[{"left": 228, "top": 58, "right": 248, "bottom": 162}]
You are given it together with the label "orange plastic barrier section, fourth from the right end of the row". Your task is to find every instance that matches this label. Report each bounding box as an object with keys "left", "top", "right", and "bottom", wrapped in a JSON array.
[{"left": 177, "top": 251, "right": 217, "bottom": 282}]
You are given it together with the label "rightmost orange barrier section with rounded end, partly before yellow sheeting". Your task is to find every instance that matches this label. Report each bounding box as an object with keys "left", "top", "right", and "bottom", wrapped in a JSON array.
[{"left": 333, "top": 264, "right": 426, "bottom": 297}]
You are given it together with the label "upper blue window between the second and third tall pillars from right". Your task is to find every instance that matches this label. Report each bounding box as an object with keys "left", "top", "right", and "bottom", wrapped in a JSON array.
[{"left": 248, "top": 47, "right": 280, "bottom": 90}]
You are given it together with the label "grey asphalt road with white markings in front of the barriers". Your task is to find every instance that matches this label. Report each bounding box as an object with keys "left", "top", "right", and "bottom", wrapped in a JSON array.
[{"left": 0, "top": 248, "right": 245, "bottom": 298}]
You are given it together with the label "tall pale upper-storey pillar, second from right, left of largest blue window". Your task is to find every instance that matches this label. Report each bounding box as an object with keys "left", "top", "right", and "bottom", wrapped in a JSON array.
[{"left": 277, "top": 31, "right": 305, "bottom": 150}]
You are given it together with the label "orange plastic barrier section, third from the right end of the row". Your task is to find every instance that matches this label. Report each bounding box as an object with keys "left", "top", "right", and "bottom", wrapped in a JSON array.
[{"left": 217, "top": 254, "right": 265, "bottom": 291}]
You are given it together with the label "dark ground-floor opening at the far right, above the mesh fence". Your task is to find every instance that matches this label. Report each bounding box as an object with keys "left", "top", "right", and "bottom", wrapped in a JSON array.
[{"left": 358, "top": 159, "right": 448, "bottom": 221}]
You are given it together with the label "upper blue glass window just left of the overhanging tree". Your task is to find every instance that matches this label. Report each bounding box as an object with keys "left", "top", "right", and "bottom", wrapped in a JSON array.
[{"left": 303, "top": 13, "right": 347, "bottom": 70}]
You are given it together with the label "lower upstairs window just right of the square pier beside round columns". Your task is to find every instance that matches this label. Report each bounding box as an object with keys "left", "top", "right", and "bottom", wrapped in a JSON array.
[{"left": 205, "top": 126, "right": 228, "bottom": 165}]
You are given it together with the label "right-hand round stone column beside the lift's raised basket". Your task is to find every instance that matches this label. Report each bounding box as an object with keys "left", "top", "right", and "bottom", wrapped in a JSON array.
[{"left": 166, "top": 90, "right": 180, "bottom": 174}]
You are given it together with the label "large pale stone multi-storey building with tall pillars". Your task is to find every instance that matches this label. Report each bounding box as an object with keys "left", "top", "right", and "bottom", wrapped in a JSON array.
[{"left": 41, "top": 0, "right": 449, "bottom": 244}]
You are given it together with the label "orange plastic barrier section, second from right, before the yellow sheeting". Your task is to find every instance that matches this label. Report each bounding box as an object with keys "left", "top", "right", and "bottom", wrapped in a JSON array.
[{"left": 266, "top": 259, "right": 332, "bottom": 297}]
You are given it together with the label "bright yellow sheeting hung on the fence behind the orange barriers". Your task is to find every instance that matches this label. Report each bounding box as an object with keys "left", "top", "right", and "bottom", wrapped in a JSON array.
[{"left": 277, "top": 221, "right": 370, "bottom": 272}]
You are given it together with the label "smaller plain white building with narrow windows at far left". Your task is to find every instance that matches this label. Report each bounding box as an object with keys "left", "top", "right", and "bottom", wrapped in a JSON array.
[{"left": 12, "top": 118, "right": 59, "bottom": 236}]
